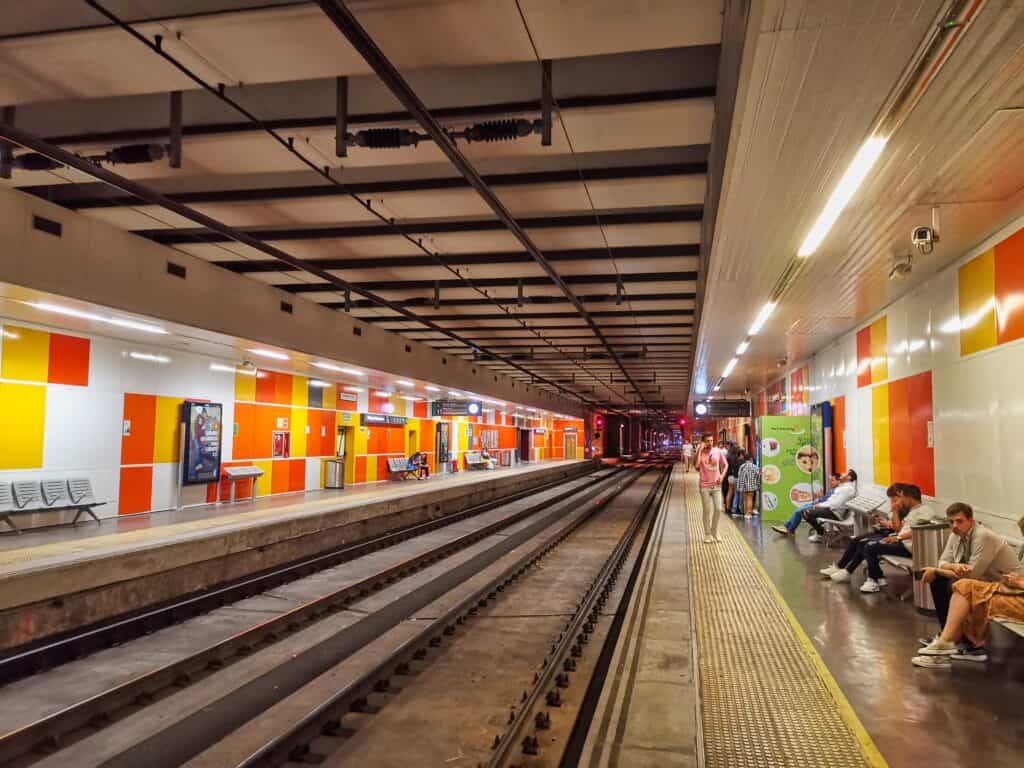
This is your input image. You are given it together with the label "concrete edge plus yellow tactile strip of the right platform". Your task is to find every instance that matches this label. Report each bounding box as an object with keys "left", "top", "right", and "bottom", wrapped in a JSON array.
[{"left": 580, "top": 467, "right": 886, "bottom": 768}]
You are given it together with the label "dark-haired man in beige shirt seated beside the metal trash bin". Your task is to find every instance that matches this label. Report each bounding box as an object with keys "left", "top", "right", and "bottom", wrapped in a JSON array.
[{"left": 921, "top": 502, "right": 1021, "bottom": 651}]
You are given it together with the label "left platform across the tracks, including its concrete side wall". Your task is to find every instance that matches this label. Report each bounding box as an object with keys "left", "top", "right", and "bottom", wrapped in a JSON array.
[{"left": 0, "top": 461, "right": 594, "bottom": 649}]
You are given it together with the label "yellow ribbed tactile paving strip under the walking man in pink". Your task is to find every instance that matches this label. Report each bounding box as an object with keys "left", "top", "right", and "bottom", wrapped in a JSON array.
[{"left": 686, "top": 474, "right": 886, "bottom": 768}]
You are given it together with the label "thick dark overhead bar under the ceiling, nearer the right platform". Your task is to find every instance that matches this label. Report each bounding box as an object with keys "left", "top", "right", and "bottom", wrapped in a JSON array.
[{"left": 317, "top": 0, "right": 645, "bottom": 403}]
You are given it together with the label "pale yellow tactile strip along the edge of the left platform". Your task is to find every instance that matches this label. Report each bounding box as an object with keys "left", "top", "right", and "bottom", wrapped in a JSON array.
[{"left": 0, "top": 461, "right": 575, "bottom": 574}]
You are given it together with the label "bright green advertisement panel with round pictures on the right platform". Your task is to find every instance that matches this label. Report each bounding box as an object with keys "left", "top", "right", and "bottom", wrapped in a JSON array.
[{"left": 758, "top": 416, "right": 822, "bottom": 522}]
